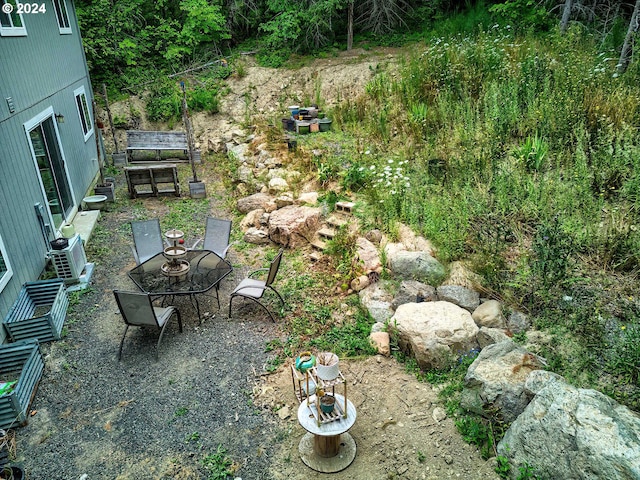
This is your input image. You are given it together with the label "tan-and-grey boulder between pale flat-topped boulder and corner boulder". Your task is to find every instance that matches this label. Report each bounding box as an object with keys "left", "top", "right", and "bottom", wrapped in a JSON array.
[{"left": 460, "top": 340, "right": 545, "bottom": 422}]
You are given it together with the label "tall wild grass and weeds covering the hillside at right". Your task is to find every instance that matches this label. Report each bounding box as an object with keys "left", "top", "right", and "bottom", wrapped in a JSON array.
[{"left": 334, "top": 21, "right": 640, "bottom": 407}]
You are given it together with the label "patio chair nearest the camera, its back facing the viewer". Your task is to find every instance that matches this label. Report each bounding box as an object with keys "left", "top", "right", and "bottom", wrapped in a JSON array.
[{"left": 113, "top": 290, "right": 182, "bottom": 361}]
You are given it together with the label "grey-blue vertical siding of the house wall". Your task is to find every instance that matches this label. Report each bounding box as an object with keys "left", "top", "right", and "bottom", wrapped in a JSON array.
[{"left": 0, "top": 0, "right": 98, "bottom": 340}]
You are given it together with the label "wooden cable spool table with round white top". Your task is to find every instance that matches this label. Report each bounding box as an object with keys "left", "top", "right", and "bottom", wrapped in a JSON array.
[{"left": 298, "top": 394, "right": 356, "bottom": 473}]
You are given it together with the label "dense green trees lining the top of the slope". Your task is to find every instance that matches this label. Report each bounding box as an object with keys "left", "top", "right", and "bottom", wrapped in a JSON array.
[{"left": 77, "top": 0, "right": 638, "bottom": 86}]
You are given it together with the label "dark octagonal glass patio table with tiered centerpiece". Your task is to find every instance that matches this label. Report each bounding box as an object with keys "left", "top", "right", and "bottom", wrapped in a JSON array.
[{"left": 129, "top": 250, "right": 233, "bottom": 321}]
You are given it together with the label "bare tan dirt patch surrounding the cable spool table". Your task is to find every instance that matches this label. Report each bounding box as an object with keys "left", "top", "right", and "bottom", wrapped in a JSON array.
[{"left": 258, "top": 356, "right": 498, "bottom": 480}]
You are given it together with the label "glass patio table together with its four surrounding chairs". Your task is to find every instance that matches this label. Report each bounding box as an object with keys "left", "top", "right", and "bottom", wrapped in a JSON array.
[{"left": 114, "top": 217, "right": 284, "bottom": 359}]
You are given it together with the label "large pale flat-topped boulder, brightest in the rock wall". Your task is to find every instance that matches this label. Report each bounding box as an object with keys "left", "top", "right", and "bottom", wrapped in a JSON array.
[{"left": 390, "top": 302, "right": 478, "bottom": 369}]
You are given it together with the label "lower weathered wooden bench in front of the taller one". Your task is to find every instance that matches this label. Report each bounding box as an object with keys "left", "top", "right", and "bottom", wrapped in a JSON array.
[{"left": 124, "top": 163, "right": 180, "bottom": 198}]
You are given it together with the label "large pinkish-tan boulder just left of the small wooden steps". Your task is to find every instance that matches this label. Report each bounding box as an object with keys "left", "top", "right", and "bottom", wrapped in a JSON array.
[{"left": 269, "top": 205, "right": 321, "bottom": 248}]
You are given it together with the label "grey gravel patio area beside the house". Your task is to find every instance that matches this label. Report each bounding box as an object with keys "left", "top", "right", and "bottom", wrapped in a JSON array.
[{"left": 16, "top": 202, "right": 280, "bottom": 480}]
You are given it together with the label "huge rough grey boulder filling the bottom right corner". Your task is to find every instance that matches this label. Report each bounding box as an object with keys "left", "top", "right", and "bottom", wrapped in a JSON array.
[{"left": 498, "top": 380, "right": 640, "bottom": 480}]
